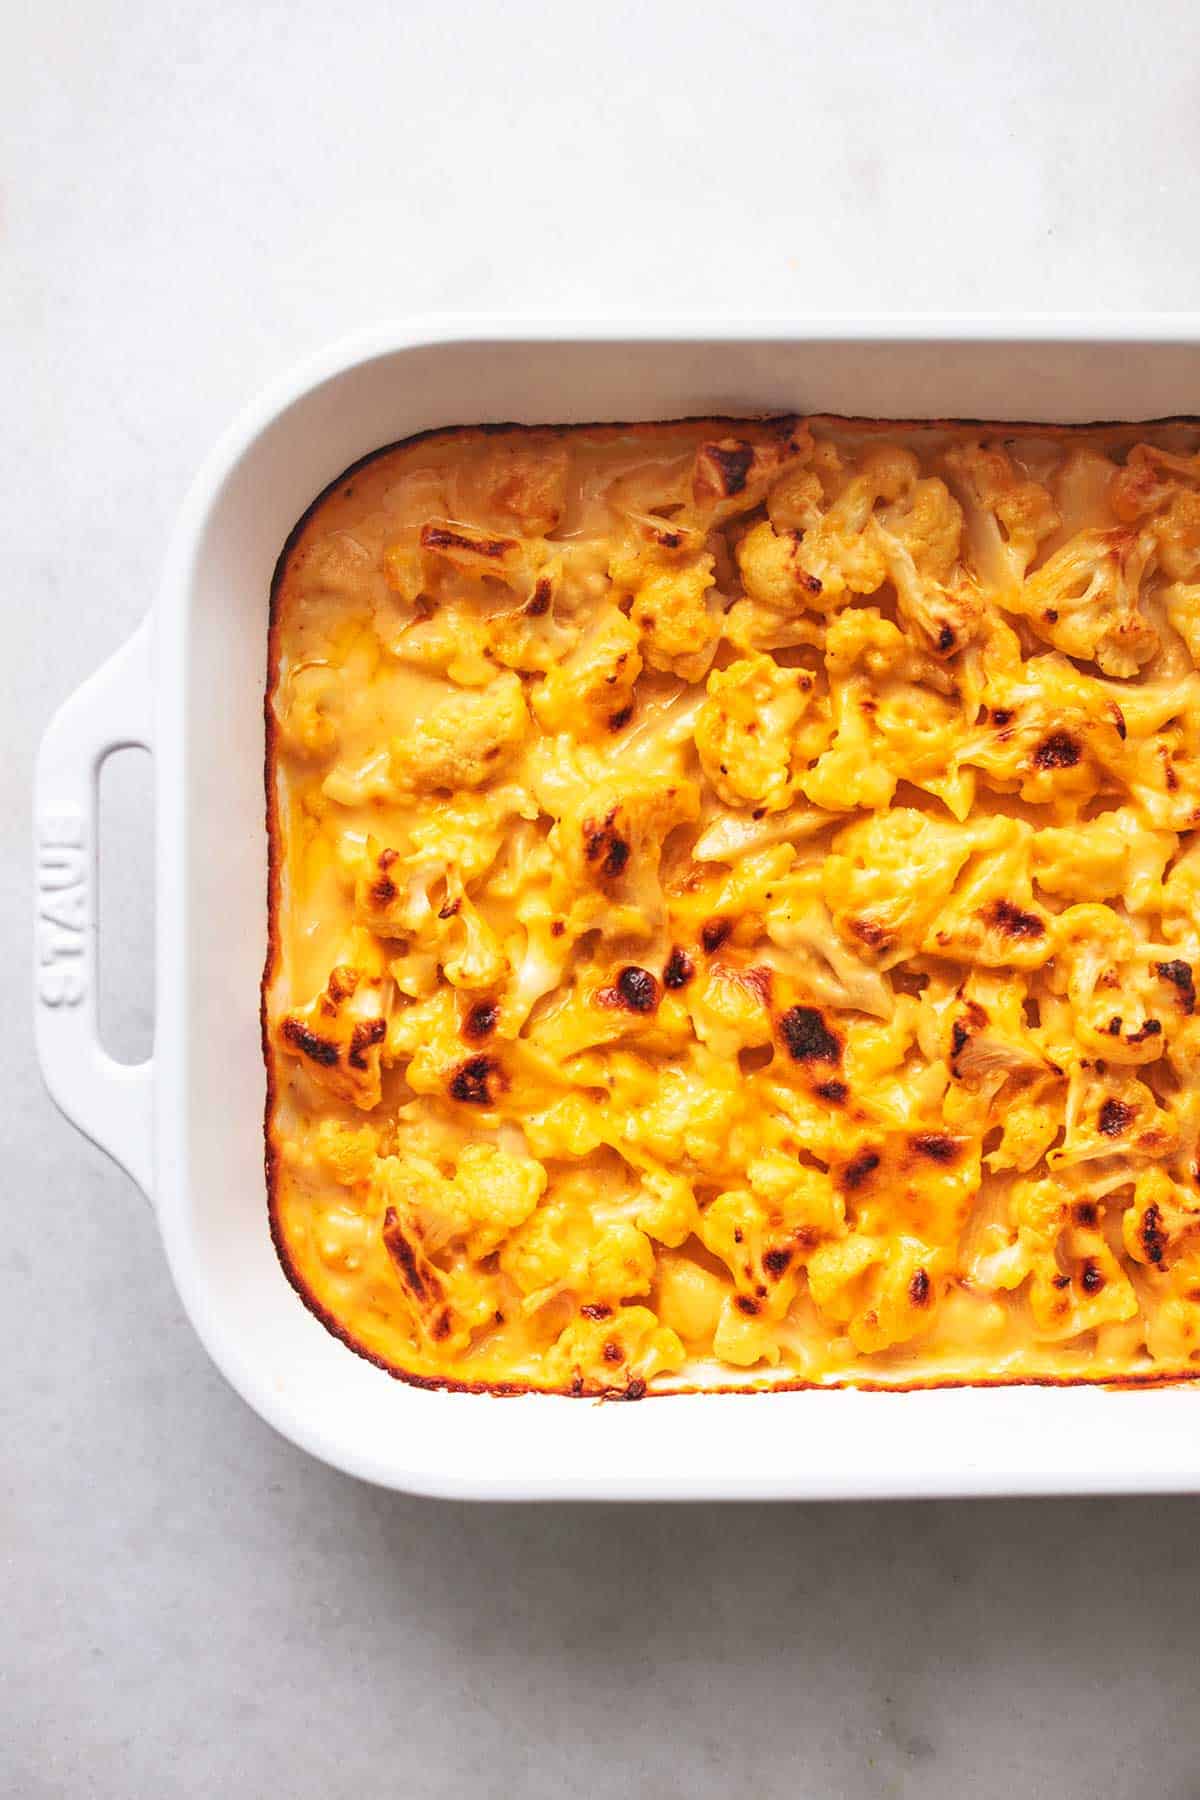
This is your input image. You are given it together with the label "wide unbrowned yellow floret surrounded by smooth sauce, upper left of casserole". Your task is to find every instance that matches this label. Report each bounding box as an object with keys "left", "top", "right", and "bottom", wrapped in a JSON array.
[{"left": 390, "top": 673, "right": 529, "bottom": 794}]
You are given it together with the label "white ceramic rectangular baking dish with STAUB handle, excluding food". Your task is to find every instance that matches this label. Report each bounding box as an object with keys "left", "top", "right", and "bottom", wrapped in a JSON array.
[{"left": 36, "top": 315, "right": 1200, "bottom": 1499}]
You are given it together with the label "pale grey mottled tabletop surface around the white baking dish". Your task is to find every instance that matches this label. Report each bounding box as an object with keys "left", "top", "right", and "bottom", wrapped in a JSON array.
[{"left": 0, "top": 0, "right": 1200, "bottom": 1800}]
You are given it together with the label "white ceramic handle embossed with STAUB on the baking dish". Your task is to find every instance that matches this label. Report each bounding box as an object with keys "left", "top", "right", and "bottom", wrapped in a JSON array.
[{"left": 34, "top": 619, "right": 153, "bottom": 1195}]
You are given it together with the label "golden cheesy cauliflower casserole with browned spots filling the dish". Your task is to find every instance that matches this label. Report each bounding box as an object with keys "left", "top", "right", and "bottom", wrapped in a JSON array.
[{"left": 263, "top": 418, "right": 1200, "bottom": 1397}]
